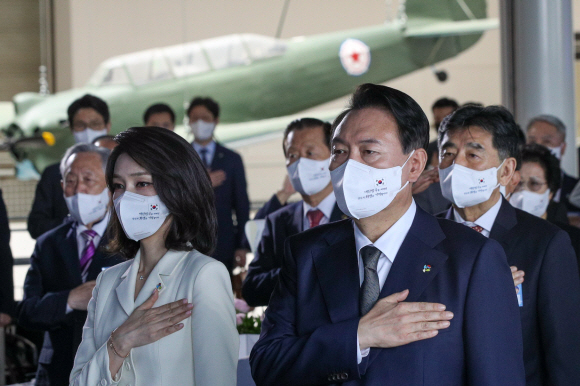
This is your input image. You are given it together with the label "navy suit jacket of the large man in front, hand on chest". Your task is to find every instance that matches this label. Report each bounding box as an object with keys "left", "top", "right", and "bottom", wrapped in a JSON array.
[{"left": 250, "top": 207, "right": 525, "bottom": 386}]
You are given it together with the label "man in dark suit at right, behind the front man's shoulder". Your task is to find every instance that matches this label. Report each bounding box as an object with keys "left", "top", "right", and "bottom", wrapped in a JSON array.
[{"left": 439, "top": 106, "right": 580, "bottom": 386}]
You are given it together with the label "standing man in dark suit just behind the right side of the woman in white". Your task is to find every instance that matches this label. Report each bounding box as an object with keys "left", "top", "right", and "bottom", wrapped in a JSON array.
[{"left": 187, "top": 97, "right": 250, "bottom": 271}]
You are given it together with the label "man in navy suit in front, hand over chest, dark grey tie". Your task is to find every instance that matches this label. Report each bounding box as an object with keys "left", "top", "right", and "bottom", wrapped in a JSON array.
[{"left": 250, "top": 84, "right": 524, "bottom": 386}]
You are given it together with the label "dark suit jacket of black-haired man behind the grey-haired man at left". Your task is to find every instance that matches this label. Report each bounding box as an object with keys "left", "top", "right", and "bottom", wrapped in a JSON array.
[{"left": 28, "top": 164, "right": 68, "bottom": 239}]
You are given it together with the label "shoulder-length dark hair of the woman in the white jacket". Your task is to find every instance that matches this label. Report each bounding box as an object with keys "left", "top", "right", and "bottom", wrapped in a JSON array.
[{"left": 106, "top": 127, "right": 217, "bottom": 258}]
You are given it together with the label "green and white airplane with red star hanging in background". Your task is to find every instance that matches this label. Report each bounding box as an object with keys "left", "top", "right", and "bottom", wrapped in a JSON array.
[{"left": 2, "top": 0, "right": 498, "bottom": 171}]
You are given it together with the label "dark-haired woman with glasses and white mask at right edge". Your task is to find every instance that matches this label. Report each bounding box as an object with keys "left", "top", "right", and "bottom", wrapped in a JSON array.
[{"left": 509, "top": 144, "right": 580, "bottom": 270}]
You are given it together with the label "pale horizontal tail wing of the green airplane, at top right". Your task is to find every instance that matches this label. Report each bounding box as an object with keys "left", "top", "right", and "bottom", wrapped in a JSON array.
[{"left": 405, "top": 19, "right": 499, "bottom": 38}]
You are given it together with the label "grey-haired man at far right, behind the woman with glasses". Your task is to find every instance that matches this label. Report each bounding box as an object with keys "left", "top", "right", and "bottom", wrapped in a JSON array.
[{"left": 526, "top": 114, "right": 580, "bottom": 213}]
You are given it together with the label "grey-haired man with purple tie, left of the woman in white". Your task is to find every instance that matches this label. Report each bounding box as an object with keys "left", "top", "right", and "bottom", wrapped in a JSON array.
[{"left": 18, "top": 143, "right": 122, "bottom": 386}]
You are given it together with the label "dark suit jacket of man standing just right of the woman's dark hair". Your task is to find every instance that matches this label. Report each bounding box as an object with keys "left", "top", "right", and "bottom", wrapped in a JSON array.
[{"left": 211, "top": 143, "right": 250, "bottom": 271}]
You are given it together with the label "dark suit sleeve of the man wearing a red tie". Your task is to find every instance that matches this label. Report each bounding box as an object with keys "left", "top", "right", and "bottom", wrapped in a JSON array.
[{"left": 242, "top": 216, "right": 283, "bottom": 307}]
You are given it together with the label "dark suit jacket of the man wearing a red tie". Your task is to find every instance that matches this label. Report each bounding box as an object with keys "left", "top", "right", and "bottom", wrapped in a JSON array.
[{"left": 242, "top": 201, "right": 343, "bottom": 307}]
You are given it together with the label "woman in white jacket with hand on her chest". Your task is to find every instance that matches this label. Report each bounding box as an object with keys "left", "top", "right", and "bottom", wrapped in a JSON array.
[{"left": 70, "top": 127, "right": 239, "bottom": 386}]
